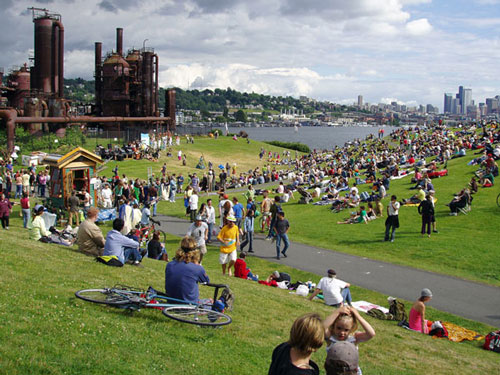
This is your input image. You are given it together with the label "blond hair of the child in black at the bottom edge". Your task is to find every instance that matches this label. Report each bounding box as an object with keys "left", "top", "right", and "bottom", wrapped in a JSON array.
[{"left": 288, "top": 313, "right": 325, "bottom": 355}]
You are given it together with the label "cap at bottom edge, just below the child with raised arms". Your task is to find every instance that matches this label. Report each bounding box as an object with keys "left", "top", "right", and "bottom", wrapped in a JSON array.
[{"left": 325, "top": 341, "right": 359, "bottom": 375}]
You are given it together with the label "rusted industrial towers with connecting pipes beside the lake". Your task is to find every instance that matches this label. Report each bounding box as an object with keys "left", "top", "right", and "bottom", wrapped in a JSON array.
[{"left": 0, "top": 8, "right": 175, "bottom": 152}]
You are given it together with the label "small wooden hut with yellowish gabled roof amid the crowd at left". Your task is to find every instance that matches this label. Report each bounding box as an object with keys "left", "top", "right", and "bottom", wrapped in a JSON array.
[{"left": 43, "top": 147, "right": 102, "bottom": 208}]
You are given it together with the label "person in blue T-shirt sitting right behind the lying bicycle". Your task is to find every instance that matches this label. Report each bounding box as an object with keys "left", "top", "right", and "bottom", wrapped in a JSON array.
[{"left": 165, "top": 236, "right": 210, "bottom": 303}]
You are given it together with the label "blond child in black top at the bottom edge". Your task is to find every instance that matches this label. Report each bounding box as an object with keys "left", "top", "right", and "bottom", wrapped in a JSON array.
[{"left": 268, "top": 313, "right": 325, "bottom": 375}]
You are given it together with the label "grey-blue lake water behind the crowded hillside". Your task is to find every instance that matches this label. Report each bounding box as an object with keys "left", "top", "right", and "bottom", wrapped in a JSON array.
[{"left": 226, "top": 126, "right": 392, "bottom": 149}]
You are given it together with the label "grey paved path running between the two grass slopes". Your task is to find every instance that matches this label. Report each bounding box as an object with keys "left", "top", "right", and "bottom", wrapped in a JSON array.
[{"left": 157, "top": 215, "right": 500, "bottom": 328}]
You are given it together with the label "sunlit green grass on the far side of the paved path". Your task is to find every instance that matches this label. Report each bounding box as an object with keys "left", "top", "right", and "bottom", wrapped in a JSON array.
[{"left": 154, "top": 145, "right": 500, "bottom": 286}]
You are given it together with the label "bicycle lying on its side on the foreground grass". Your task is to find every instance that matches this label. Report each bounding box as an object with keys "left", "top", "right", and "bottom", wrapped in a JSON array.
[{"left": 75, "top": 283, "right": 233, "bottom": 326}]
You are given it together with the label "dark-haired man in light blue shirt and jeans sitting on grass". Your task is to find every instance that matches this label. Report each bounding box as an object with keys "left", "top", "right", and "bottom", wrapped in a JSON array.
[{"left": 103, "top": 219, "right": 142, "bottom": 265}]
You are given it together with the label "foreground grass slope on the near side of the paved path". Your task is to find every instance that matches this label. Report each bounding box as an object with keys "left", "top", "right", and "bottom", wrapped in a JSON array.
[{"left": 0, "top": 217, "right": 500, "bottom": 375}]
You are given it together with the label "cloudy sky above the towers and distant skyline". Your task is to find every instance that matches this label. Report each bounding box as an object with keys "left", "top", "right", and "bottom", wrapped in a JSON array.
[{"left": 0, "top": 0, "right": 500, "bottom": 110}]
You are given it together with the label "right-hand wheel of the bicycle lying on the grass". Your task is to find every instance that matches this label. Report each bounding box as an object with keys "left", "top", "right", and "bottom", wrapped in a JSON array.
[{"left": 162, "top": 305, "right": 232, "bottom": 326}]
